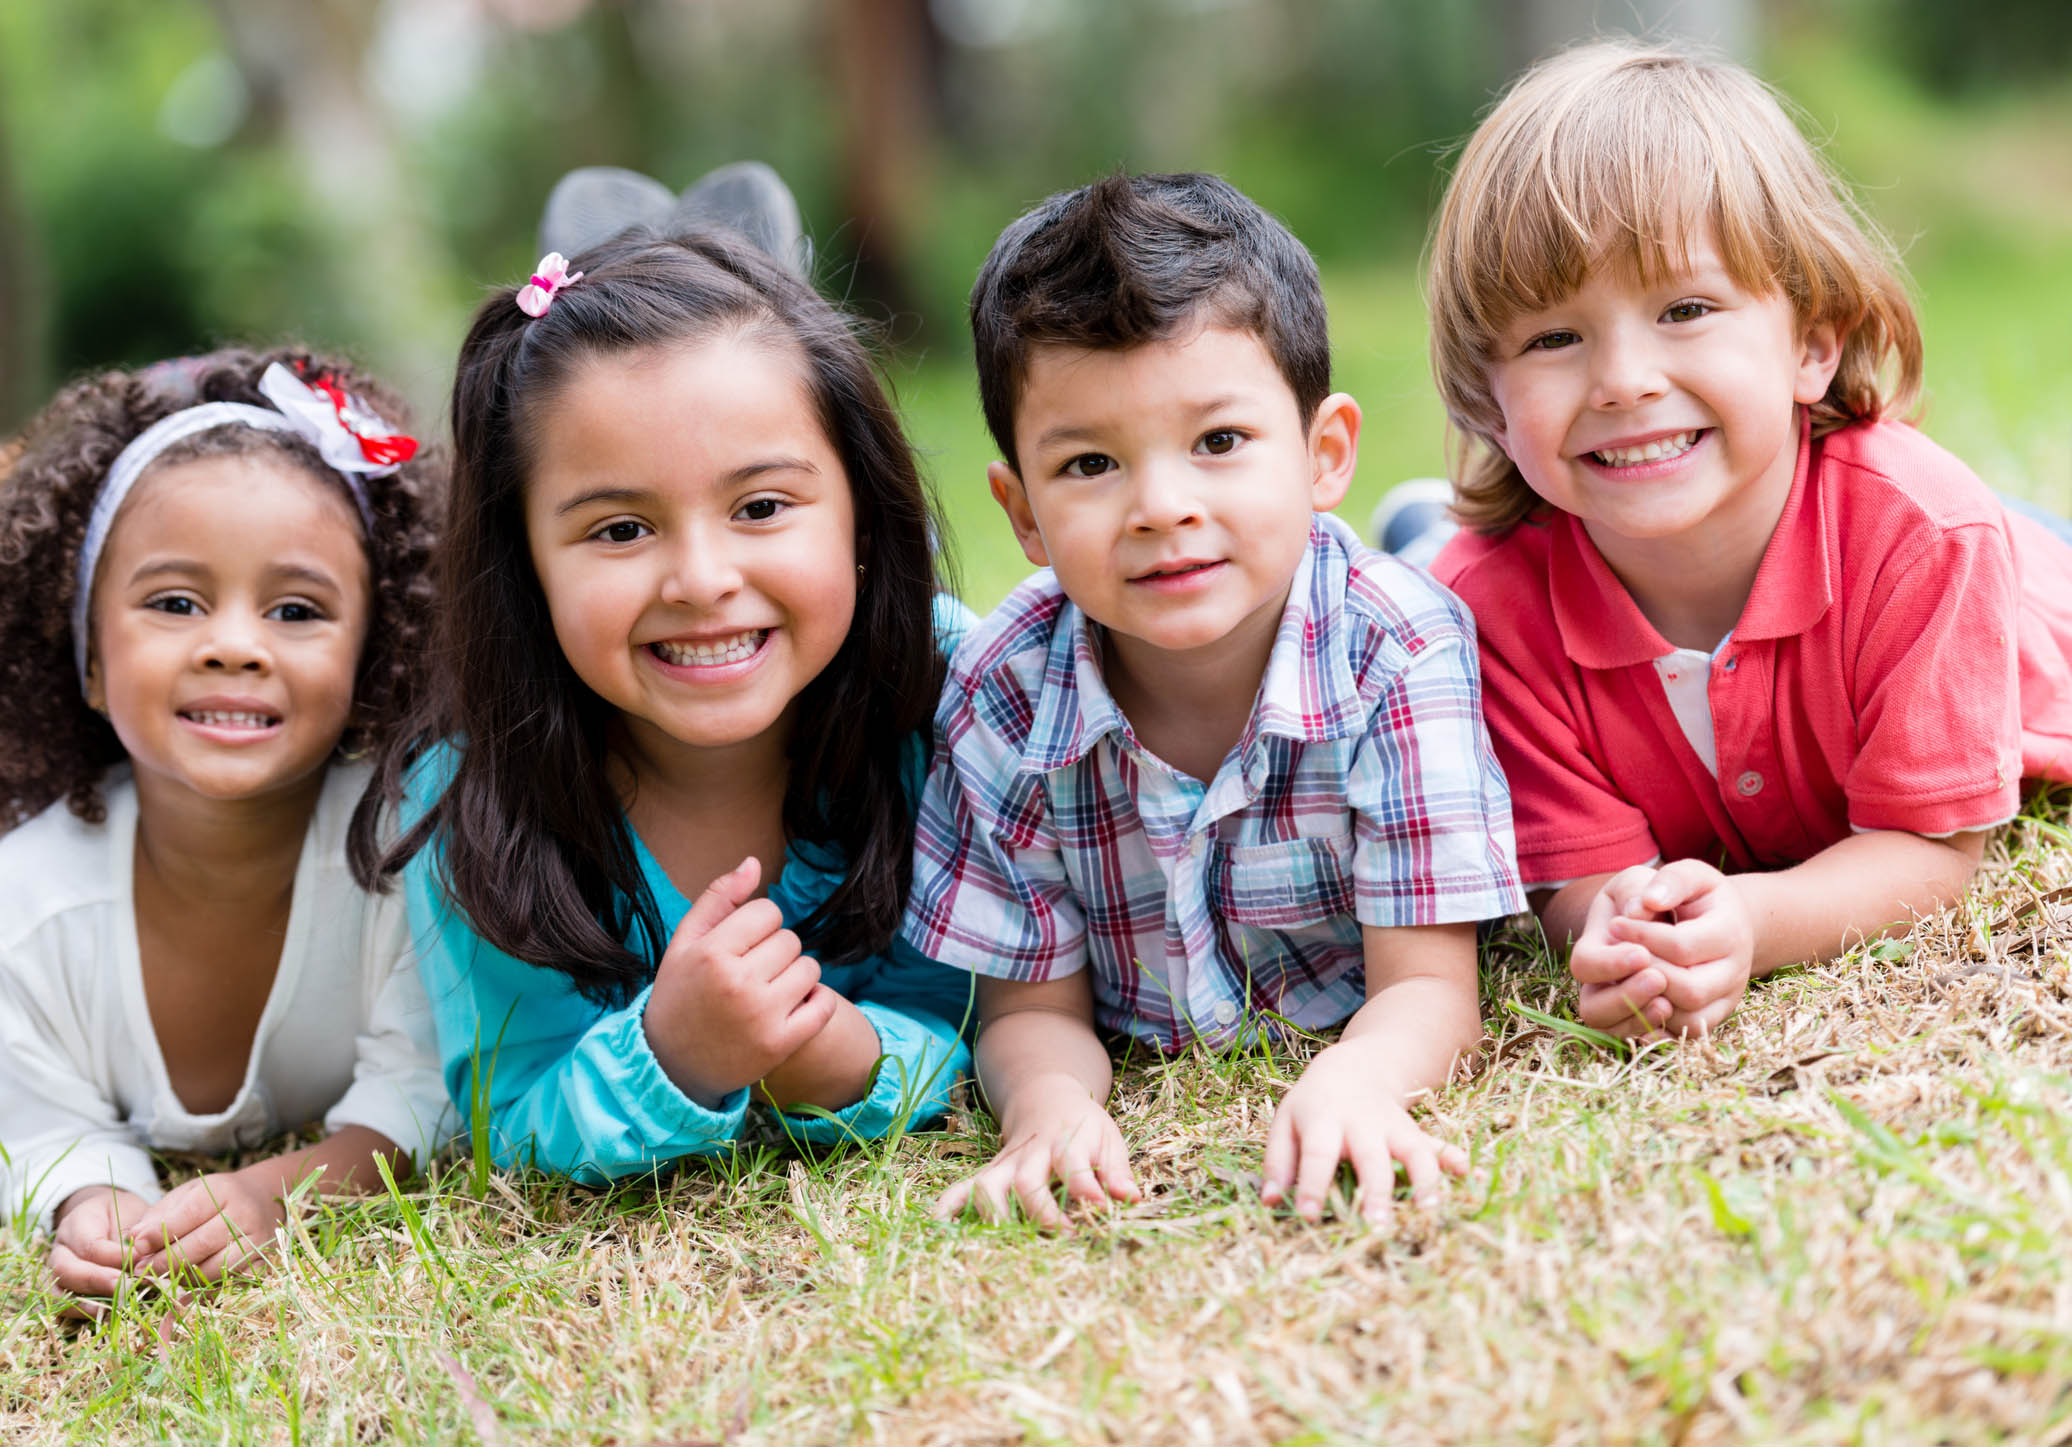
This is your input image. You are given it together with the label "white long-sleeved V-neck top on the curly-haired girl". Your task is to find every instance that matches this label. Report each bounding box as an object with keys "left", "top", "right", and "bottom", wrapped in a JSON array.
[{"left": 0, "top": 765, "right": 454, "bottom": 1231}]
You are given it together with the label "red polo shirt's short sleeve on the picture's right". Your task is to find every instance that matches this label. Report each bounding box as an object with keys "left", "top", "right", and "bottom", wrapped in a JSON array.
[{"left": 1842, "top": 522, "right": 2022, "bottom": 835}]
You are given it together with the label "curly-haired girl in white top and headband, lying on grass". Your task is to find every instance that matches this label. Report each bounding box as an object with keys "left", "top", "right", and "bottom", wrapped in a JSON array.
[{"left": 0, "top": 350, "right": 448, "bottom": 1296}]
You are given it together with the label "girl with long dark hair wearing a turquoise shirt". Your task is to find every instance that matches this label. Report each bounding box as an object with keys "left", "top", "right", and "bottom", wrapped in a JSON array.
[{"left": 361, "top": 228, "right": 968, "bottom": 1180}]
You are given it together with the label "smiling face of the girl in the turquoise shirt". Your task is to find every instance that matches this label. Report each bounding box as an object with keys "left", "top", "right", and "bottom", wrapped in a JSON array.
[{"left": 524, "top": 336, "right": 856, "bottom": 762}]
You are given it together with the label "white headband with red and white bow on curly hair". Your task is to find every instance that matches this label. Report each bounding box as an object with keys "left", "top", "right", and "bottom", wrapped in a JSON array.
[{"left": 73, "top": 363, "right": 416, "bottom": 690}]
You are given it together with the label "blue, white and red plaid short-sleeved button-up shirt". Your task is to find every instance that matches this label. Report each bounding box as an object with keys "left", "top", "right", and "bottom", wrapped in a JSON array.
[{"left": 905, "top": 518, "right": 1525, "bottom": 1049}]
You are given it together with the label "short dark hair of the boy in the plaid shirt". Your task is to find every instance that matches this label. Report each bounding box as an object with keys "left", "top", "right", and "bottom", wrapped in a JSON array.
[{"left": 972, "top": 172, "right": 1330, "bottom": 466}]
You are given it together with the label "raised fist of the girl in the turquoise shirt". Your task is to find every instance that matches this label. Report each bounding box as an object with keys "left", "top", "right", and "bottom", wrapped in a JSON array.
[{"left": 642, "top": 858, "right": 839, "bottom": 1105}]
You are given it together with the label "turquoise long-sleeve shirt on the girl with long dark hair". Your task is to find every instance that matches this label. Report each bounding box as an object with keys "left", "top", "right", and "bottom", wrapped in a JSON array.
[{"left": 404, "top": 738, "right": 976, "bottom": 1184}]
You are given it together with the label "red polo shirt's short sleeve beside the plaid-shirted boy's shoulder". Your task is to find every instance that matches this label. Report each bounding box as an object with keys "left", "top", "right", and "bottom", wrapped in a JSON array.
[{"left": 1477, "top": 584, "right": 1662, "bottom": 889}]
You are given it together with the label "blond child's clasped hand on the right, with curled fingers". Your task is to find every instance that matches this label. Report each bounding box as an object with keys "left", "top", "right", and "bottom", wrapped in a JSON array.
[{"left": 1606, "top": 858, "right": 1755, "bottom": 1037}]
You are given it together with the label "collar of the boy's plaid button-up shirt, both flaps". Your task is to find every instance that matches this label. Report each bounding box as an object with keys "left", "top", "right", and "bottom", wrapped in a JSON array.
[{"left": 1019, "top": 516, "right": 1363, "bottom": 773}]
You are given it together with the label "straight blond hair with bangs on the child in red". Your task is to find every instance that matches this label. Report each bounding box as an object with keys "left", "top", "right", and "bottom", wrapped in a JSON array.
[{"left": 1428, "top": 41, "right": 1921, "bottom": 531}]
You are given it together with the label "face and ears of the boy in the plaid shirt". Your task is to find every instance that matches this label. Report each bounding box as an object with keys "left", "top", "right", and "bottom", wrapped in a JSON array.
[{"left": 988, "top": 328, "right": 1359, "bottom": 653}]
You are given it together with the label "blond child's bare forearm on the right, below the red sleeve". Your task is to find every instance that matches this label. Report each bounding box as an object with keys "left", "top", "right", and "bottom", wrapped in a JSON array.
[{"left": 1732, "top": 829, "right": 1985, "bottom": 976}]
